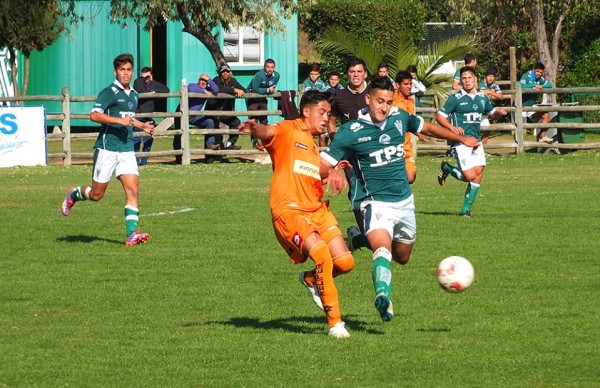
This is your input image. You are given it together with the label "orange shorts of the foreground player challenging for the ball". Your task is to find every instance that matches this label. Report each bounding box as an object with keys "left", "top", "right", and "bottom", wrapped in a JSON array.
[{"left": 273, "top": 203, "right": 342, "bottom": 264}]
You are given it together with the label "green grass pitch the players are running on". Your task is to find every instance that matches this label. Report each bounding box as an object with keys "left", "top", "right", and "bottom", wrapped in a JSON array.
[{"left": 0, "top": 151, "right": 600, "bottom": 387}]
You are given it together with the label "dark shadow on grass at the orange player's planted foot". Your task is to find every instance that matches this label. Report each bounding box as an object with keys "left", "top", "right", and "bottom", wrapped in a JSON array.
[{"left": 196, "top": 316, "right": 384, "bottom": 334}]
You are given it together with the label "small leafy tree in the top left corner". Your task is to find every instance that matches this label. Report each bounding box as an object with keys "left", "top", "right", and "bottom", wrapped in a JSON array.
[{"left": 0, "top": 0, "right": 65, "bottom": 96}]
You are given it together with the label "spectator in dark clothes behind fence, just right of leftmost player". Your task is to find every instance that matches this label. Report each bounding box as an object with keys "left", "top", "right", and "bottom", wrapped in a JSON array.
[{"left": 133, "top": 67, "right": 169, "bottom": 166}]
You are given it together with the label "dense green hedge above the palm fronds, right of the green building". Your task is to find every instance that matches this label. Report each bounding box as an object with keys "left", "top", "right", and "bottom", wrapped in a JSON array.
[{"left": 301, "top": 0, "right": 424, "bottom": 50}]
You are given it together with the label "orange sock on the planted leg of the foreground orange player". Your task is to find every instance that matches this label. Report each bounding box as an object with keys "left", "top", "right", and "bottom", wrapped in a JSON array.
[{"left": 309, "top": 241, "right": 342, "bottom": 327}]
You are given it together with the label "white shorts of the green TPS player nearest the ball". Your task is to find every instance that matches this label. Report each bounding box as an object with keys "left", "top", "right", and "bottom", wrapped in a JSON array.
[{"left": 360, "top": 194, "right": 417, "bottom": 244}]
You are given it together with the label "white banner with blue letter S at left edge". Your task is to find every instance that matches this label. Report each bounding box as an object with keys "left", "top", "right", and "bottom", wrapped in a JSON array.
[{"left": 0, "top": 106, "right": 48, "bottom": 167}]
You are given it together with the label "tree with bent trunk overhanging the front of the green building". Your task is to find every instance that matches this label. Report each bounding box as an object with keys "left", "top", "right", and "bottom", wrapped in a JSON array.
[{"left": 107, "top": 0, "right": 297, "bottom": 68}]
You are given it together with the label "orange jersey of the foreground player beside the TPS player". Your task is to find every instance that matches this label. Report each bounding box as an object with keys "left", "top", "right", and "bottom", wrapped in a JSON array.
[{"left": 263, "top": 119, "right": 323, "bottom": 218}]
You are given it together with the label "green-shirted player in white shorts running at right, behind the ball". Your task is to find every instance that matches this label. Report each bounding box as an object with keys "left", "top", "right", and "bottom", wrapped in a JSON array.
[{"left": 435, "top": 66, "right": 506, "bottom": 217}]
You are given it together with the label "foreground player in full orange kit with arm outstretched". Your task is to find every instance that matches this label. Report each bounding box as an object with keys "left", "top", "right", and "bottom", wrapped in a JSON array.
[{"left": 240, "top": 90, "right": 354, "bottom": 338}]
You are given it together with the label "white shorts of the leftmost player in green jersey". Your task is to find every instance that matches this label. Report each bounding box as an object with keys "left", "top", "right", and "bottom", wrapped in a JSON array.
[{"left": 92, "top": 148, "right": 140, "bottom": 183}]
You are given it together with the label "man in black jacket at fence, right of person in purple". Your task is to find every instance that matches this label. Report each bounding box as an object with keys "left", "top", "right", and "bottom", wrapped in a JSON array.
[{"left": 207, "top": 64, "right": 246, "bottom": 150}]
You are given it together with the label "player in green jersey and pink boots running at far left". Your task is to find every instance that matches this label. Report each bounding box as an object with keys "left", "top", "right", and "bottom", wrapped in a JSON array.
[{"left": 61, "top": 54, "right": 154, "bottom": 246}]
